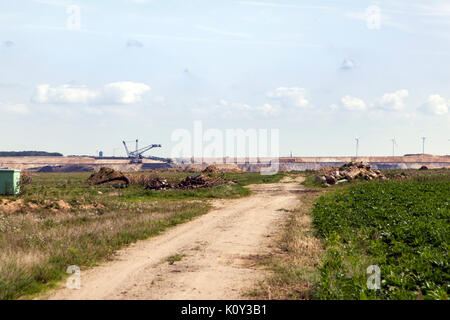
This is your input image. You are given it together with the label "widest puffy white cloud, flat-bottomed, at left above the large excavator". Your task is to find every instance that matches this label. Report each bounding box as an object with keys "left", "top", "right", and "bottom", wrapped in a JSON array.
[{"left": 32, "top": 81, "right": 150, "bottom": 104}]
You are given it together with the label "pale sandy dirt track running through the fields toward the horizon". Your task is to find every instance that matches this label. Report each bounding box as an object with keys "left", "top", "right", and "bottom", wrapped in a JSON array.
[{"left": 42, "top": 178, "right": 303, "bottom": 299}]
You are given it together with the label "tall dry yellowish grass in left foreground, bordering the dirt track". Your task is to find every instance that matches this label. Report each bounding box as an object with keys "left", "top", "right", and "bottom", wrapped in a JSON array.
[{"left": 0, "top": 199, "right": 209, "bottom": 299}]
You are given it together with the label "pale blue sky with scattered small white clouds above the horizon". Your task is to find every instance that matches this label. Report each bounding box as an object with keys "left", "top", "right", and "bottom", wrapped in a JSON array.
[{"left": 0, "top": 0, "right": 450, "bottom": 156}]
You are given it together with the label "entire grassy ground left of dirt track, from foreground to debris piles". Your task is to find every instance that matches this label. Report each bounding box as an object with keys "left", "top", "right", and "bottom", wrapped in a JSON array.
[{"left": 0, "top": 172, "right": 283, "bottom": 299}]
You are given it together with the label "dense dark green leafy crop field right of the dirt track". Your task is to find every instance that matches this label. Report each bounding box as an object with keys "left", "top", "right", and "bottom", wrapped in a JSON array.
[{"left": 312, "top": 171, "right": 450, "bottom": 299}]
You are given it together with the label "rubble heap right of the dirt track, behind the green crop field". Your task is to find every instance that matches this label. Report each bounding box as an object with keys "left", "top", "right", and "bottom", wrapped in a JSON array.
[{"left": 316, "top": 161, "right": 386, "bottom": 187}]
